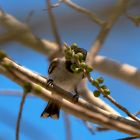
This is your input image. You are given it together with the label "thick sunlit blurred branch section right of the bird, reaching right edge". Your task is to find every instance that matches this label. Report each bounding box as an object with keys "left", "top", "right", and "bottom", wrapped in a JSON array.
[{"left": 92, "top": 56, "right": 140, "bottom": 88}]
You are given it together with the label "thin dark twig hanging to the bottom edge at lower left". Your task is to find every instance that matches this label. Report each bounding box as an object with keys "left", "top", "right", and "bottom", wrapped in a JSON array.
[{"left": 16, "top": 93, "right": 27, "bottom": 140}]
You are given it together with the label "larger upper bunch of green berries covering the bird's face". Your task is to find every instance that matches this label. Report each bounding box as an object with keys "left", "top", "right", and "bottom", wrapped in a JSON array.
[{"left": 65, "top": 43, "right": 93, "bottom": 73}]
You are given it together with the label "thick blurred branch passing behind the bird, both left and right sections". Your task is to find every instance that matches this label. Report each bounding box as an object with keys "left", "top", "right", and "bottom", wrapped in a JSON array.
[{"left": 0, "top": 12, "right": 140, "bottom": 88}]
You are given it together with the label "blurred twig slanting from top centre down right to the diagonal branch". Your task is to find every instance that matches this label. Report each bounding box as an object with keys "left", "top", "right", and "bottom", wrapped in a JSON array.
[{"left": 62, "top": 0, "right": 104, "bottom": 26}]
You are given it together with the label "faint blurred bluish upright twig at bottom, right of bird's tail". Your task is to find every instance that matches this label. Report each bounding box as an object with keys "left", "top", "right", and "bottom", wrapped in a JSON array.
[{"left": 63, "top": 112, "right": 72, "bottom": 140}]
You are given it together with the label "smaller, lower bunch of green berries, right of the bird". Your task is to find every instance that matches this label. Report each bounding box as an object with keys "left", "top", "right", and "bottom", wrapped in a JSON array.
[{"left": 91, "top": 77, "right": 110, "bottom": 97}]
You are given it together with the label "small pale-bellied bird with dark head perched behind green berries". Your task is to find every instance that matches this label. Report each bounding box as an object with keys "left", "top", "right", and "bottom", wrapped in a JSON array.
[{"left": 41, "top": 48, "right": 87, "bottom": 119}]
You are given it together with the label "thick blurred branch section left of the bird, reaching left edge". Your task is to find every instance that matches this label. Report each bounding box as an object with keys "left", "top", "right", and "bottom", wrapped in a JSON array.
[{"left": 0, "top": 11, "right": 58, "bottom": 57}]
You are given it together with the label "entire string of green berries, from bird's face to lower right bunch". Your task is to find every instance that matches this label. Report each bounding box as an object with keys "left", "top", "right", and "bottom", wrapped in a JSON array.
[{"left": 65, "top": 43, "right": 110, "bottom": 97}]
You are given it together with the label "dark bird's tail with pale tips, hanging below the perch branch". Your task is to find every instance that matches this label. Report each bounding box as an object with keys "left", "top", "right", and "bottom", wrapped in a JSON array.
[{"left": 41, "top": 100, "right": 60, "bottom": 119}]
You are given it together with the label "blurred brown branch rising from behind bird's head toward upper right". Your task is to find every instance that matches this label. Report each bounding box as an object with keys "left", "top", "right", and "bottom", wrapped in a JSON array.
[{"left": 87, "top": 0, "right": 129, "bottom": 66}]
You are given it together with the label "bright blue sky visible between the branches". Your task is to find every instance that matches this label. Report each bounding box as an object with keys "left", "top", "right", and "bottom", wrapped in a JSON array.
[{"left": 0, "top": 0, "right": 140, "bottom": 140}]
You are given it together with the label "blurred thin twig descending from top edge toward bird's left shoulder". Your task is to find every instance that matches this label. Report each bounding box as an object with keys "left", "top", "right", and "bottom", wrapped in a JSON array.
[{"left": 46, "top": 0, "right": 62, "bottom": 51}]
